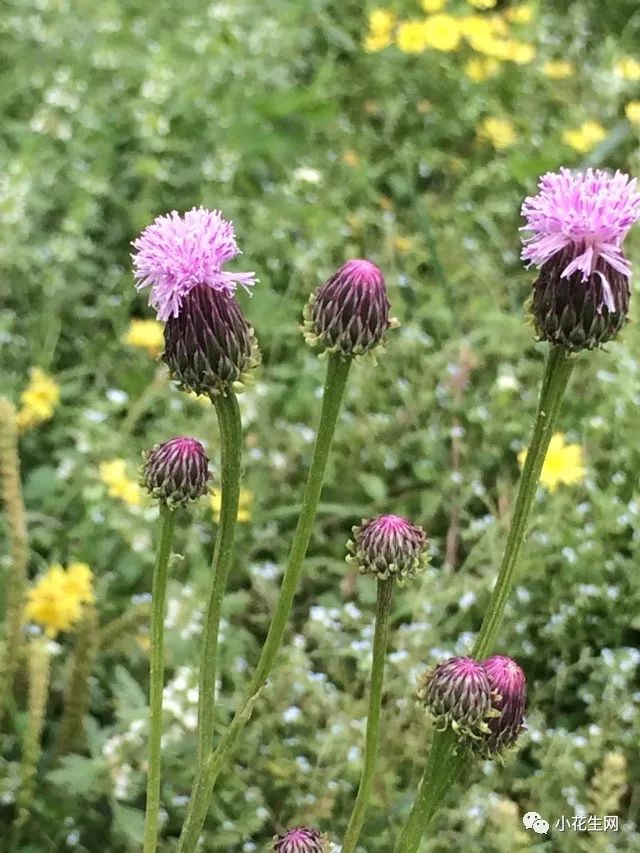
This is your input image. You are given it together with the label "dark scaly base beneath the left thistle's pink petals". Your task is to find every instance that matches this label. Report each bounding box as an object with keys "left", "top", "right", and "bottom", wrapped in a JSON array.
[{"left": 163, "top": 284, "right": 260, "bottom": 397}]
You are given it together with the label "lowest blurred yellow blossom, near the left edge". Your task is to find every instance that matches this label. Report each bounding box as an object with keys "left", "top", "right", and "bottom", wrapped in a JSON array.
[{"left": 25, "top": 563, "right": 94, "bottom": 637}]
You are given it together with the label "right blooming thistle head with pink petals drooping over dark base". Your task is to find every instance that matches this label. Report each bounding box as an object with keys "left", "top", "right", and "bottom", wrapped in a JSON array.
[{"left": 521, "top": 169, "right": 640, "bottom": 351}]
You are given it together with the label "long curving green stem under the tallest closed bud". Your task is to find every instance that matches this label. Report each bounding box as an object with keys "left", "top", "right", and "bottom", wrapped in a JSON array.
[{"left": 178, "top": 355, "right": 351, "bottom": 853}]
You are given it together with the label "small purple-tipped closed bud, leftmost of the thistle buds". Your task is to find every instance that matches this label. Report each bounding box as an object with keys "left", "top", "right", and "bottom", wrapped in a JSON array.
[{"left": 142, "top": 436, "right": 209, "bottom": 506}]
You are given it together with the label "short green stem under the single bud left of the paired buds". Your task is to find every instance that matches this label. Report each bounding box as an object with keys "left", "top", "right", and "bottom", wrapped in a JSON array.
[{"left": 342, "top": 578, "right": 395, "bottom": 853}]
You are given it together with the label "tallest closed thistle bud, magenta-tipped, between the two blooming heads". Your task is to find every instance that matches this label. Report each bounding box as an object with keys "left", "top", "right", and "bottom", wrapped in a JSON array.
[{"left": 303, "top": 260, "right": 397, "bottom": 358}]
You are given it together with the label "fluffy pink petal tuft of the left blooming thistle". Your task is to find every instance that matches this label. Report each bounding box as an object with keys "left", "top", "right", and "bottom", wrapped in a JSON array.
[{"left": 131, "top": 207, "right": 256, "bottom": 321}]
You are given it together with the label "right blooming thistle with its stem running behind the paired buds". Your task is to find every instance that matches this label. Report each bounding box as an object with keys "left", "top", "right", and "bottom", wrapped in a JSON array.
[{"left": 396, "top": 169, "right": 640, "bottom": 853}]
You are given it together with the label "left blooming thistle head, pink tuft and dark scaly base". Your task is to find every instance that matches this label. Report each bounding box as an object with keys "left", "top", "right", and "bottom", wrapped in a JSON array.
[{"left": 132, "top": 207, "right": 260, "bottom": 397}]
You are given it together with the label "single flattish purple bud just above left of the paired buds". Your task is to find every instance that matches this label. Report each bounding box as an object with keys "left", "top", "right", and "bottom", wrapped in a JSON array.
[{"left": 347, "top": 515, "right": 428, "bottom": 583}]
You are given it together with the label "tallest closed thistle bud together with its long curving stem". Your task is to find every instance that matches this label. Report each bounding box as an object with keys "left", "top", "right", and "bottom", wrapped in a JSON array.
[{"left": 179, "top": 260, "right": 392, "bottom": 853}]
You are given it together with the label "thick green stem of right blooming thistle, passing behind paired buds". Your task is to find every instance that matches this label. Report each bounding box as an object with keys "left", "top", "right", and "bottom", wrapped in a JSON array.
[{"left": 396, "top": 346, "right": 574, "bottom": 853}]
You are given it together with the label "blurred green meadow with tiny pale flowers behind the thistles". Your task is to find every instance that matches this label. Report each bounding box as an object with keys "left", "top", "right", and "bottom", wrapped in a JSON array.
[{"left": 0, "top": 0, "right": 640, "bottom": 853}]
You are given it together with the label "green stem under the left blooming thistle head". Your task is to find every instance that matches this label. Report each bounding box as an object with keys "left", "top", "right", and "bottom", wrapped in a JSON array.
[{"left": 197, "top": 390, "right": 242, "bottom": 768}]
